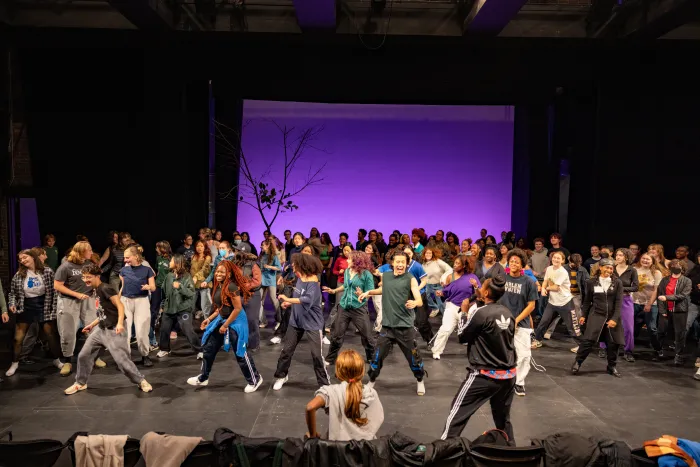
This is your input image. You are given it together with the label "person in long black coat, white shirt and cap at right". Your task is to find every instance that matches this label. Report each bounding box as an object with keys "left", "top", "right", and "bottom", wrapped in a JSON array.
[{"left": 571, "top": 258, "right": 625, "bottom": 378}]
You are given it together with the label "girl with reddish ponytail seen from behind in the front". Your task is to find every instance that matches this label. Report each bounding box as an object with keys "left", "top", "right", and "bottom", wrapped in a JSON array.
[{"left": 306, "top": 350, "right": 384, "bottom": 441}]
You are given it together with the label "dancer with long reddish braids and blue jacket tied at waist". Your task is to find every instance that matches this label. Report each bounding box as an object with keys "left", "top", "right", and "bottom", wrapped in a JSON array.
[{"left": 187, "top": 260, "right": 263, "bottom": 393}]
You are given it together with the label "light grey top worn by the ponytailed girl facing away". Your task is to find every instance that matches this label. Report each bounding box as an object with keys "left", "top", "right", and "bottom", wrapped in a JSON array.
[{"left": 316, "top": 381, "right": 384, "bottom": 441}]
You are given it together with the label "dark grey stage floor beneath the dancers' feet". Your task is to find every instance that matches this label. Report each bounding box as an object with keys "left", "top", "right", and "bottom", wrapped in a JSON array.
[{"left": 0, "top": 323, "right": 700, "bottom": 447}]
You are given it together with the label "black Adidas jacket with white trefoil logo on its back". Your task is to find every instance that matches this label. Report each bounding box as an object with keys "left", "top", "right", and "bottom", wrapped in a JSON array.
[{"left": 459, "top": 303, "right": 515, "bottom": 371}]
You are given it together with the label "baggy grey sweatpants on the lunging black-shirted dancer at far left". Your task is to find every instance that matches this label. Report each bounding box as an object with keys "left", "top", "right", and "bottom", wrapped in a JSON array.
[{"left": 75, "top": 328, "right": 145, "bottom": 384}]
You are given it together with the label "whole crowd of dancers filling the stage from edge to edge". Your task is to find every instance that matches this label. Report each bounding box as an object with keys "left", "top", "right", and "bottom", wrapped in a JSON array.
[{"left": 0, "top": 228, "right": 700, "bottom": 446}]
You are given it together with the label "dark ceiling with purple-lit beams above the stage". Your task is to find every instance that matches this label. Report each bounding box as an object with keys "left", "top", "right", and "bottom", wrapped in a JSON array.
[{"left": 0, "top": 0, "right": 700, "bottom": 39}]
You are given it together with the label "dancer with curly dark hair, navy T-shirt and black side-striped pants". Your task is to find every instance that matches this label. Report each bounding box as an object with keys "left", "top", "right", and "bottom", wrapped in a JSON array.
[{"left": 272, "top": 253, "right": 330, "bottom": 391}]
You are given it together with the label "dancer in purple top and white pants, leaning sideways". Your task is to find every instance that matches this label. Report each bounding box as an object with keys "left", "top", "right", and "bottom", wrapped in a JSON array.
[{"left": 426, "top": 254, "right": 481, "bottom": 360}]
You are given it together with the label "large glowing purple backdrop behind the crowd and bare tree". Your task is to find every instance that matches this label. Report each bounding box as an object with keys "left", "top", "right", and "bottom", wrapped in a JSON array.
[{"left": 238, "top": 101, "right": 513, "bottom": 246}]
